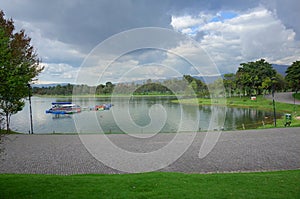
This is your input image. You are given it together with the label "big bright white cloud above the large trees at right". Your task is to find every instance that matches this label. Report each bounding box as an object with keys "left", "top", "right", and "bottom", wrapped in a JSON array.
[{"left": 171, "top": 7, "right": 300, "bottom": 72}]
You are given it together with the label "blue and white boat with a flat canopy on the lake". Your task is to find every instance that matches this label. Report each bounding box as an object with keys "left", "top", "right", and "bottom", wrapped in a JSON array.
[{"left": 46, "top": 102, "right": 81, "bottom": 114}]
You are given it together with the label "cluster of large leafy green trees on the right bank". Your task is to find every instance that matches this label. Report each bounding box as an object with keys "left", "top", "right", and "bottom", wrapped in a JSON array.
[{"left": 223, "top": 59, "right": 300, "bottom": 97}]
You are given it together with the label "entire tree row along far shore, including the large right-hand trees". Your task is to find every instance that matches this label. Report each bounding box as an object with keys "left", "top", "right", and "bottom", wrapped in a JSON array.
[{"left": 33, "top": 59, "right": 300, "bottom": 97}]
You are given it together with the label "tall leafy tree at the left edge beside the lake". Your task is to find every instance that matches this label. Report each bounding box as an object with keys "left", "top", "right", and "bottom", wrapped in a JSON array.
[{"left": 0, "top": 10, "right": 43, "bottom": 131}]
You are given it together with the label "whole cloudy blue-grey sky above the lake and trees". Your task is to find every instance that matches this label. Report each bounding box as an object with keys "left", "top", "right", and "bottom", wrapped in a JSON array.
[{"left": 0, "top": 0, "right": 300, "bottom": 84}]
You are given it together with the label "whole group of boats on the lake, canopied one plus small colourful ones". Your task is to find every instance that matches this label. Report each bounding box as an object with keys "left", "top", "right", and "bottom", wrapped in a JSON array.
[{"left": 46, "top": 102, "right": 113, "bottom": 114}]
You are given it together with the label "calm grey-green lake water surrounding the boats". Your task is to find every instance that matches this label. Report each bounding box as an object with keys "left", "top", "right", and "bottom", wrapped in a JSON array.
[{"left": 11, "top": 97, "right": 272, "bottom": 134}]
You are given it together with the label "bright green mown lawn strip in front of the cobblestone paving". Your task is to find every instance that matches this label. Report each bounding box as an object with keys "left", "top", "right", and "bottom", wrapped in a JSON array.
[{"left": 0, "top": 170, "right": 300, "bottom": 198}]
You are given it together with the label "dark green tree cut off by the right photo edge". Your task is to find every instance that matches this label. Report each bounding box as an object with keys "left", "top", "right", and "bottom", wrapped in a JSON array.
[{"left": 285, "top": 61, "right": 300, "bottom": 91}]
